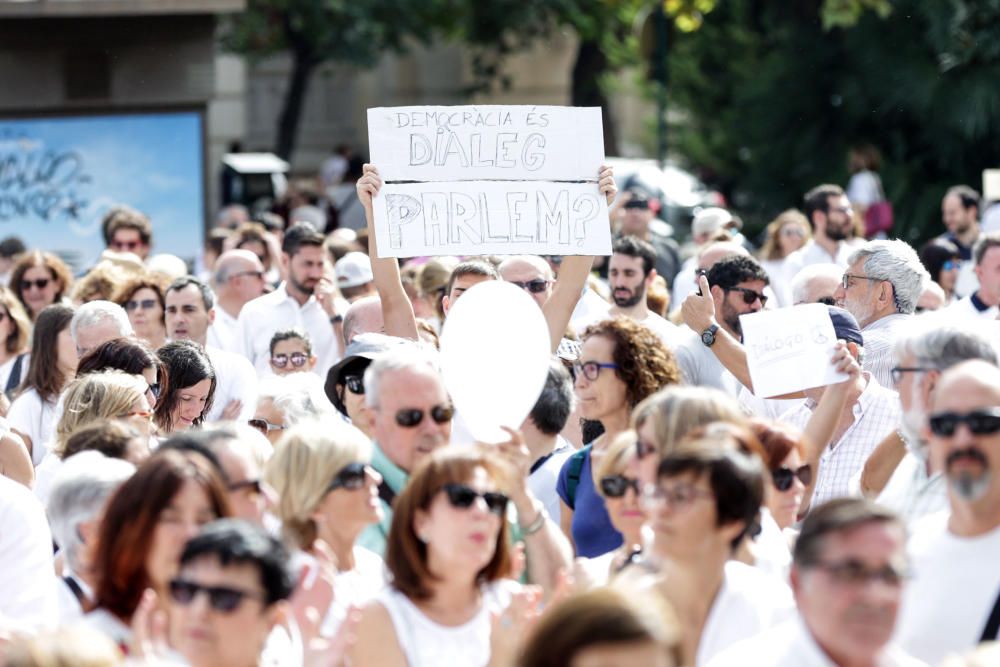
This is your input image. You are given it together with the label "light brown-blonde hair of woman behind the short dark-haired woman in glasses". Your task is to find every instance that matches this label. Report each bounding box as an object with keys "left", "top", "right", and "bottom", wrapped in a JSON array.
[{"left": 632, "top": 386, "right": 747, "bottom": 458}]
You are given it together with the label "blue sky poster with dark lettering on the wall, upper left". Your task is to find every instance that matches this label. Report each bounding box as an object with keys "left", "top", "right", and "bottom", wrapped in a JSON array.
[{"left": 0, "top": 112, "right": 205, "bottom": 272}]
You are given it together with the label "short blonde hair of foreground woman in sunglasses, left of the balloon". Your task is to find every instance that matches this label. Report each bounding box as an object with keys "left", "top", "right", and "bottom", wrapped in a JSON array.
[{"left": 264, "top": 419, "right": 372, "bottom": 549}]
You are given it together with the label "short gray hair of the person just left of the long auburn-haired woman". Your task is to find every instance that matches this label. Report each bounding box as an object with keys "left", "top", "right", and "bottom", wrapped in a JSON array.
[{"left": 46, "top": 450, "right": 135, "bottom": 573}]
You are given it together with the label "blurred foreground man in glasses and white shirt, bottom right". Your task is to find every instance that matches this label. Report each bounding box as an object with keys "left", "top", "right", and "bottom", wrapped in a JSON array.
[{"left": 708, "top": 498, "right": 933, "bottom": 667}]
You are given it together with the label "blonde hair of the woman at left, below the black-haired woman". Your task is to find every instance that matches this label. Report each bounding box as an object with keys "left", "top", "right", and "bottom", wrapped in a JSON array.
[{"left": 55, "top": 370, "right": 146, "bottom": 458}]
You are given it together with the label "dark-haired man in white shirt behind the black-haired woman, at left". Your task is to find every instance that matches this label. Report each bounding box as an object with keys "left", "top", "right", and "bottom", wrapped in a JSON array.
[{"left": 164, "top": 276, "right": 257, "bottom": 422}]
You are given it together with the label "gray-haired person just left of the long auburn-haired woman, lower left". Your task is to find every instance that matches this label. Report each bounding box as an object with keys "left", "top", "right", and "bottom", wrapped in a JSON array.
[{"left": 47, "top": 450, "right": 135, "bottom": 625}]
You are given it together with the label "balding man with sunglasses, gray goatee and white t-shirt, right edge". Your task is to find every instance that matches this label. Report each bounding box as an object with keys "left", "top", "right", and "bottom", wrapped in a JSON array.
[{"left": 899, "top": 360, "right": 1000, "bottom": 665}]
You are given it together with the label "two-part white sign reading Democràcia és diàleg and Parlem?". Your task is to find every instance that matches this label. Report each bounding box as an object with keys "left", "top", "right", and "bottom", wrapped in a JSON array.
[{"left": 368, "top": 106, "right": 611, "bottom": 257}]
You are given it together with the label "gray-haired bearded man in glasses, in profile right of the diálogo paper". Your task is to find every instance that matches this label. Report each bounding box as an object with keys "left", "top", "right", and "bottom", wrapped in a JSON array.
[{"left": 833, "top": 240, "right": 930, "bottom": 387}]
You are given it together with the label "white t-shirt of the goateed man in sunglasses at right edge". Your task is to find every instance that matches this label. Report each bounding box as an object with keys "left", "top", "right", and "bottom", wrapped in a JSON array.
[{"left": 896, "top": 511, "right": 1000, "bottom": 665}]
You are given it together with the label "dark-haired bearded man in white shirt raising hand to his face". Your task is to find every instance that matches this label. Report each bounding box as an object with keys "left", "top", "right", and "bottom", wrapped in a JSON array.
[{"left": 236, "top": 222, "right": 343, "bottom": 378}]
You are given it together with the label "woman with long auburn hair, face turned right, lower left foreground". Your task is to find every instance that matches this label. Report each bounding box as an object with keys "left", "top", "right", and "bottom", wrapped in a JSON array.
[{"left": 85, "top": 450, "right": 232, "bottom": 650}]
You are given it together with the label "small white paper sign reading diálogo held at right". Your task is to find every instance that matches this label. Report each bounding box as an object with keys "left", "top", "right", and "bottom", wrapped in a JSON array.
[{"left": 740, "top": 303, "right": 847, "bottom": 398}]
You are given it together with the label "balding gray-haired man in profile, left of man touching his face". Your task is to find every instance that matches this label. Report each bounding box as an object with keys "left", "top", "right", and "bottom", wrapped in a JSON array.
[{"left": 207, "top": 249, "right": 264, "bottom": 352}]
